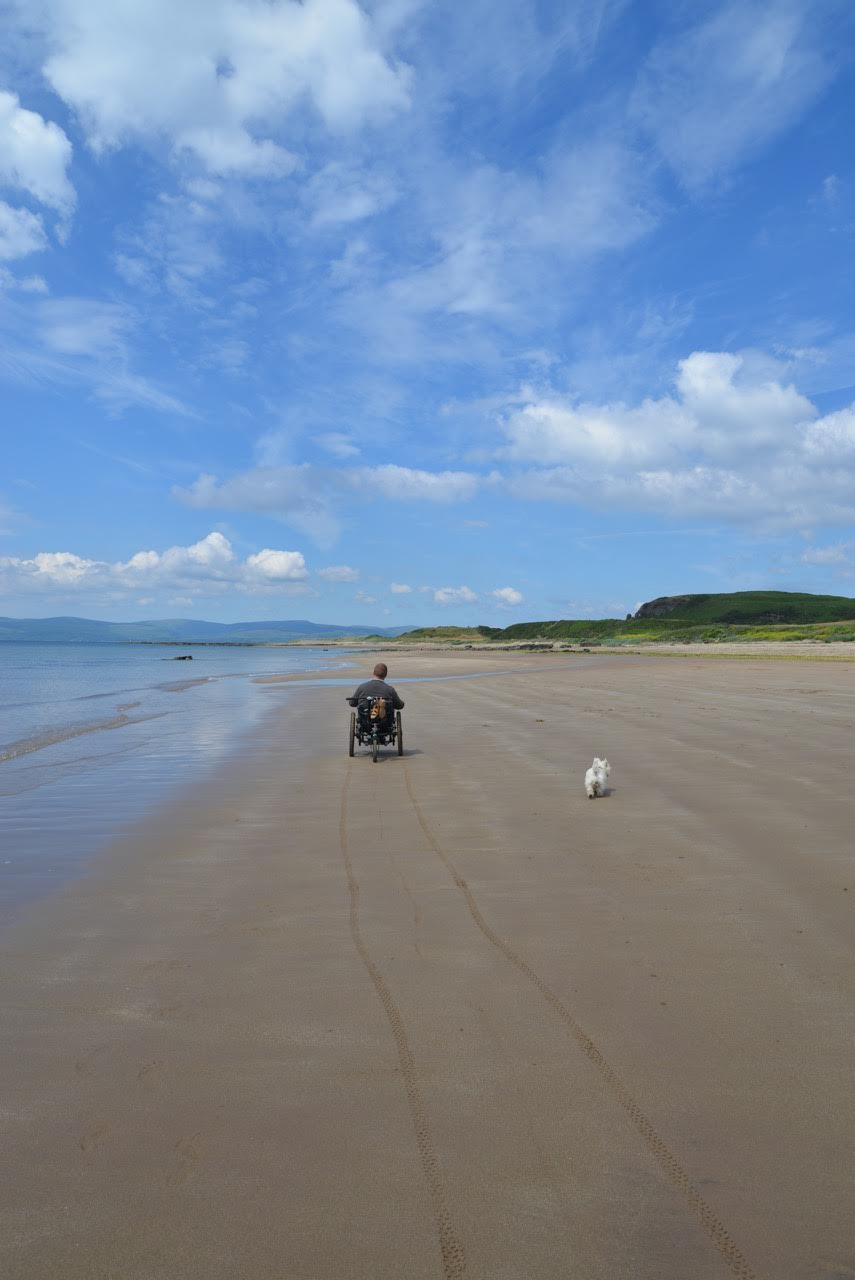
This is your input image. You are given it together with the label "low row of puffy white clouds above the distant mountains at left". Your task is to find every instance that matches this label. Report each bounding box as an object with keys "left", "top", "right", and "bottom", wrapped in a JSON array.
[{"left": 0, "top": 531, "right": 308, "bottom": 595}]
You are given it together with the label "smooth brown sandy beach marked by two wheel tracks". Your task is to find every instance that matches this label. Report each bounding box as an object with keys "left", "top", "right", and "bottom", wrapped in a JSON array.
[{"left": 0, "top": 654, "right": 855, "bottom": 1280}]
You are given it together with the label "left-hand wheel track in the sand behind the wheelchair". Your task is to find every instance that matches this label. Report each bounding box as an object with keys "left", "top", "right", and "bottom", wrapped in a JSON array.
[{"left": 339, "top": 760, "right": 466, "bottom": 1280}]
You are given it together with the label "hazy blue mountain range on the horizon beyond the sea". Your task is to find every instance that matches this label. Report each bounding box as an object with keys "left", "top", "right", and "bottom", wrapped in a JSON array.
[{"left": 0, "top": 618, "right": 412, "bottom": 644}]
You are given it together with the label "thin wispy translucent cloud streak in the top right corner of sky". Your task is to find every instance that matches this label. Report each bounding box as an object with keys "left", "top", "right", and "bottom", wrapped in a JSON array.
[{"left": 632, "top": 0, "right": 832, "bottom": 188}]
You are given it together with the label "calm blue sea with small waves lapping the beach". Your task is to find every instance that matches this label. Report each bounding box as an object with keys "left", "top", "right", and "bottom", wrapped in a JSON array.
[{"left": 0, "top": 643, "right": 356, "bottom": 924}]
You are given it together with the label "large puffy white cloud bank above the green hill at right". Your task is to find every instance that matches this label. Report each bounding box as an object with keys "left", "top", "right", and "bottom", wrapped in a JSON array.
[{"left": 499, "top": 352, "right": 855, "bottom": 527}]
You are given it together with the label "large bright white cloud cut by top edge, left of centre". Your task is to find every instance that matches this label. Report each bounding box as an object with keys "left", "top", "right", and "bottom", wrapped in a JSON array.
[{"left": 42, "top": 0, "right": 410, "bottom": 178}]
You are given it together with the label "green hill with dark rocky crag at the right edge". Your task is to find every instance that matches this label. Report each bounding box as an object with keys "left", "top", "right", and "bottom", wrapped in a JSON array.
[{"left": 634, "top": 591, "right": 855, "bottom": 626}]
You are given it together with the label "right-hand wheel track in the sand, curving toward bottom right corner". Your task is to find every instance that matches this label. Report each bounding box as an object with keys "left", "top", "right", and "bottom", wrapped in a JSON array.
[{"left": 403, "top": 759, "right": 759, "bottom": 1280}]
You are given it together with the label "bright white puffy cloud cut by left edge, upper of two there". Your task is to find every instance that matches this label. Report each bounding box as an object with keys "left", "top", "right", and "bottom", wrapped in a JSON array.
[{"left": 0, "top": 90, "right": 76, "bottom": 216}]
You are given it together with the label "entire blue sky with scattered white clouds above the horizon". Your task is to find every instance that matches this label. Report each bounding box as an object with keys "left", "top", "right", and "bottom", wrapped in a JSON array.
[{"left": 0, "top": 0, "right": 855, "bottom": 626}]
